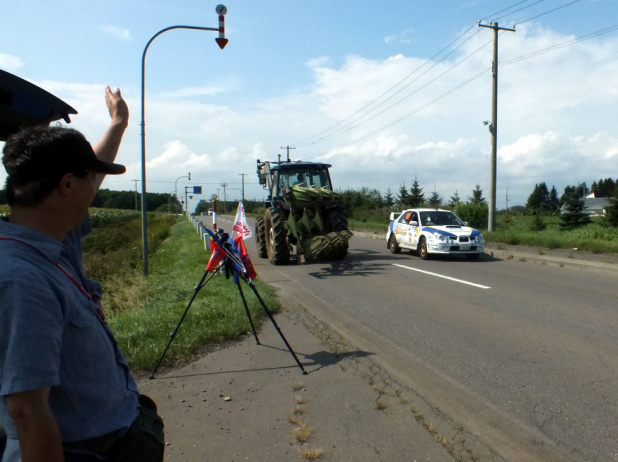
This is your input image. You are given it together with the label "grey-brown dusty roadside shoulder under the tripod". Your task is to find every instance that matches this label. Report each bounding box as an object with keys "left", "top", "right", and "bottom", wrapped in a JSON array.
[{"left": 138, "top": 306, "right": 462, "bottom": 462}]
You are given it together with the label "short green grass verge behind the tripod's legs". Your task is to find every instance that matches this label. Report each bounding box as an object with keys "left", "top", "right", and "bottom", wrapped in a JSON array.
[{"left": 85, "top": 218, "right": 278, "bottom": 370}]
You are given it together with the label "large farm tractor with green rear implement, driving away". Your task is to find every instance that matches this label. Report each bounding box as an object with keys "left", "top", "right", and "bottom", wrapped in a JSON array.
[{"left": 255, "top": 160, "right": 352, "bottom": 265}]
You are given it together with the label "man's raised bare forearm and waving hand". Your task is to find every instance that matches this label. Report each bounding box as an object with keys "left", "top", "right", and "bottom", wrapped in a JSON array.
[{"left": 93, "top": 86, "right": 129, "bottom": 187}]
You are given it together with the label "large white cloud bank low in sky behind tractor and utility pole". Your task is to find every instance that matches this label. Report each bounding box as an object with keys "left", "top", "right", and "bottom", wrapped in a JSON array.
[{"left": 4, "top": 24, "right": 618, "bottom": 207}]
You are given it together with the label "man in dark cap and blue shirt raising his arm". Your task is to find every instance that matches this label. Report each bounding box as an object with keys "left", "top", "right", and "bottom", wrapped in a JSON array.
[{"left": 0, "top": 87, "right": 164, "bottom": 462}]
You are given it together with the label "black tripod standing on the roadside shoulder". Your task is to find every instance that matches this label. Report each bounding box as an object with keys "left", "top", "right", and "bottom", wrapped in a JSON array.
[{"left": 150, "top": 228, "right": 307, "bottom": 379}]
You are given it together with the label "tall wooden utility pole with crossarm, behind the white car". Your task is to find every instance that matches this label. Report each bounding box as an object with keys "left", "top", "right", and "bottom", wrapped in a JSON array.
[{"left": 479, "top": 22, "right": 515, "bottom": 232}]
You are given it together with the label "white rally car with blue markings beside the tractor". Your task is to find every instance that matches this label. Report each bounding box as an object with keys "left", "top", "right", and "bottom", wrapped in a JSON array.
[{"left": 386, "top": 209, "right": 485, "bottom": 260}]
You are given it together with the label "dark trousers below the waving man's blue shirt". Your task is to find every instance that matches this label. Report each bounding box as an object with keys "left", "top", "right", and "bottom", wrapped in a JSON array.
[{"left": 64, "top": 395, "right": 165, "bottom": 462}]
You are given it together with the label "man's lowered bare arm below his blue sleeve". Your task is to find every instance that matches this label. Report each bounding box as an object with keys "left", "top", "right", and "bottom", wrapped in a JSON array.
[{"left": 6, "top": 388, "right": 64, "bottom": 462}]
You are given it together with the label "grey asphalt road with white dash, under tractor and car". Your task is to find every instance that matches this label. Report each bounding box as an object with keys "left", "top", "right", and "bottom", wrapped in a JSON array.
[{"left": 205, "top": 217, "right": 618, "bottom": 461}]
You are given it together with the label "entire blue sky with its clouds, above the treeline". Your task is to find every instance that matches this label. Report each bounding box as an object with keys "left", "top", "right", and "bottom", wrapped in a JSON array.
[{"left": 0, "top": 0, "right": 618, "bottom": 208}]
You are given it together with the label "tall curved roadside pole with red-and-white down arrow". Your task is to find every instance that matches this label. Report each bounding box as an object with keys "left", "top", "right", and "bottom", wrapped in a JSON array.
[{"left": 140, "top": 5, "right": 227, "bottom": 276}]
